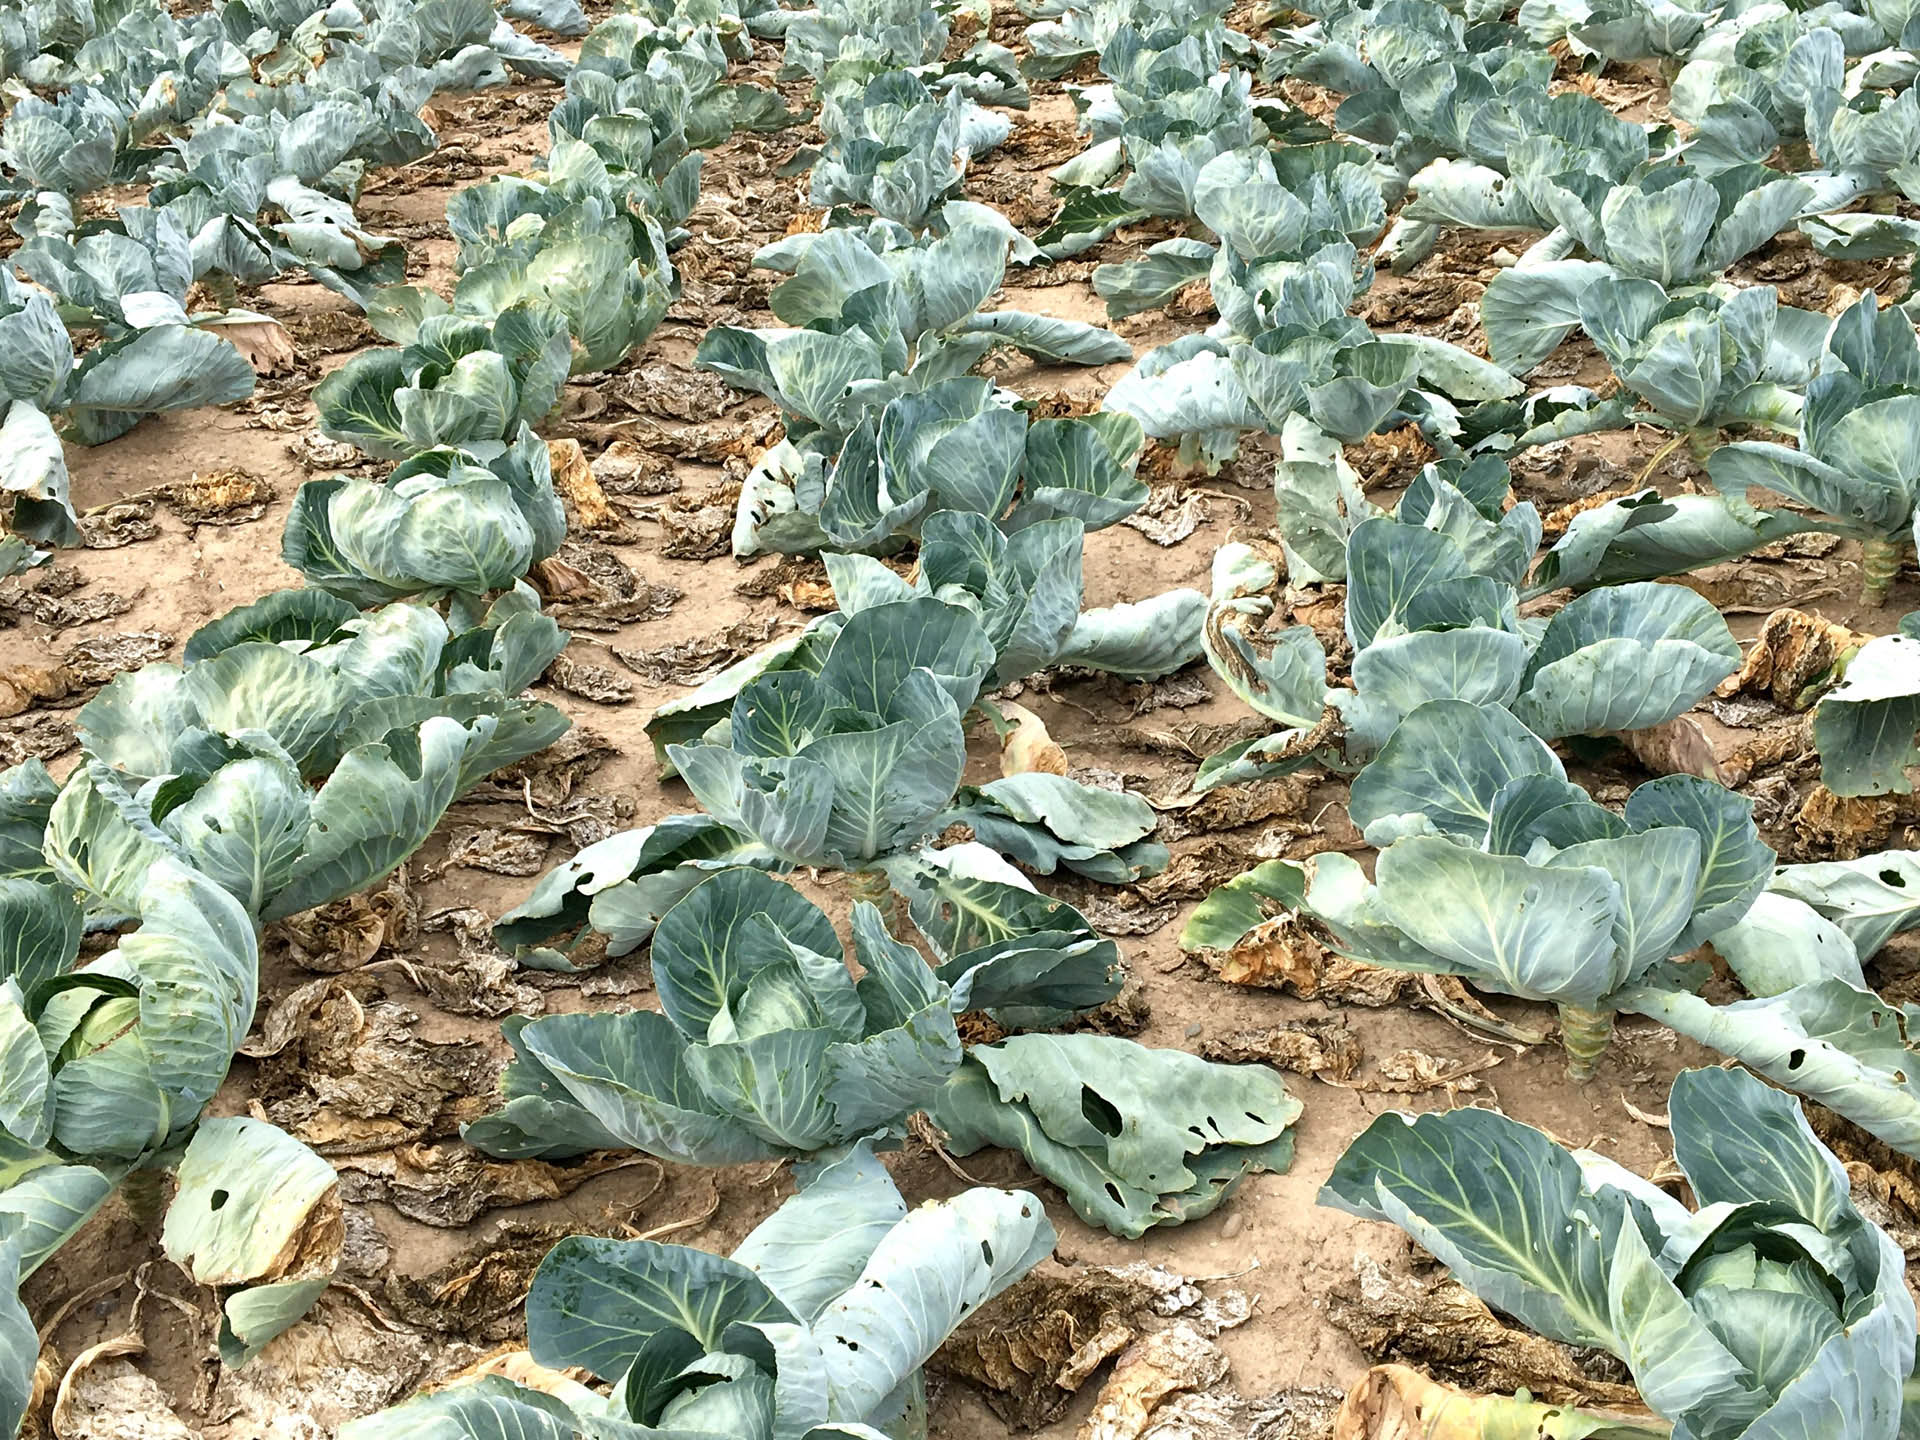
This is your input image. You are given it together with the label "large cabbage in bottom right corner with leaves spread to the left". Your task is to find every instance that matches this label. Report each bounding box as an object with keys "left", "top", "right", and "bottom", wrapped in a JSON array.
[{"left": 1321, "top": 1069, "right": 1914, "bottom": 1440}]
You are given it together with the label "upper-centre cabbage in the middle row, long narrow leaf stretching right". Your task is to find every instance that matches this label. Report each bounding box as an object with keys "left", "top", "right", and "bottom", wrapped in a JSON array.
[{"left": 697, "top": 214, "right": 1133, "bottom": 455}]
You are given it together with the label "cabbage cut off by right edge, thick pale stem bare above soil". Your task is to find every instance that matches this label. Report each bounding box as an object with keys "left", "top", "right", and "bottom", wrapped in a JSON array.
[{"left": 1707, "top": 296, "right": 1920, "bottom": 605}]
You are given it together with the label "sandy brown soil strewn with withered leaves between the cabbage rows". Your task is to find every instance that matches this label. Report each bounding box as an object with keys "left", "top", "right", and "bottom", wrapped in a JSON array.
[{"left": 11, "top": 8, "right": 1920, "bottom": 1440}]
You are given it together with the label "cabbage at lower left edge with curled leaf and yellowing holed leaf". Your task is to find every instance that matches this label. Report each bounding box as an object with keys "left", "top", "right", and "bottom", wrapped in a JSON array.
[{"left": 0, "top": 860, "right": 340, "bottom": 1419}]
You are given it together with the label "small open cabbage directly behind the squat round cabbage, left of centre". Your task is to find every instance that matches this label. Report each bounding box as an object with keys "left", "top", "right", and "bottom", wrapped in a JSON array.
[{"left": 313, "top": 301, "right": 572, "bottom": 461}]
